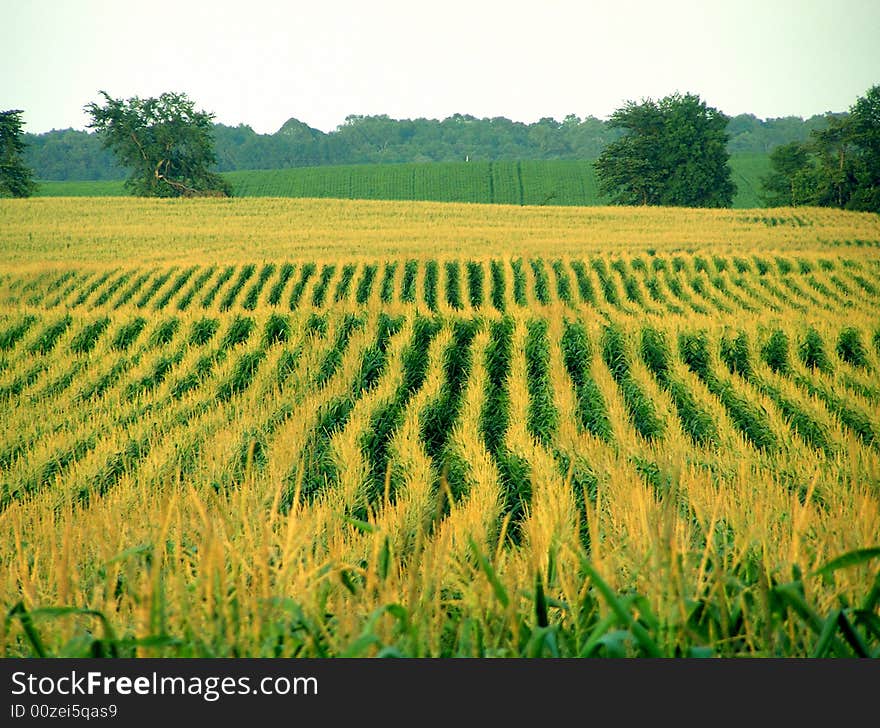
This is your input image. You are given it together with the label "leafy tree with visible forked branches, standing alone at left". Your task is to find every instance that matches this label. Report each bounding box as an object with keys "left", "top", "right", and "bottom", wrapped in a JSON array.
[{"left": 85, "top": 91, "right": 232, "bottom": 197}]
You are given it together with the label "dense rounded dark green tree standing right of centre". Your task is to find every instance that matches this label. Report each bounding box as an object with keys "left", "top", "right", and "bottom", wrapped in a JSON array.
[{"left": 596, "top": 94, "right": 736, "bottom": 207}]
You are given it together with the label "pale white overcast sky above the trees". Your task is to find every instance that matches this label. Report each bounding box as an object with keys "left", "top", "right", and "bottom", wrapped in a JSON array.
[{"left": 0, "top": 0, "right": 880, "bottom": 133}]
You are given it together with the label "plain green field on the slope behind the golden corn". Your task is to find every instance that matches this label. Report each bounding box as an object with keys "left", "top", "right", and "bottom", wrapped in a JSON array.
[{"left": 37, "top": 154, "right": 770, "bottom": 208}]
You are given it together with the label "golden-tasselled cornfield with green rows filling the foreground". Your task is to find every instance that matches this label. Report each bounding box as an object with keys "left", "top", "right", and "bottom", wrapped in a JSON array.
[{"left": 0, "top": 199, "right": 880, "bottom": 657}]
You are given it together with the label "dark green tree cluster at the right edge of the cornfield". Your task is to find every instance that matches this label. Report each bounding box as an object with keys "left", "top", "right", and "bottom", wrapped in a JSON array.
[{"left": 762, "top": 85, "right": 880, "bottom": 212}]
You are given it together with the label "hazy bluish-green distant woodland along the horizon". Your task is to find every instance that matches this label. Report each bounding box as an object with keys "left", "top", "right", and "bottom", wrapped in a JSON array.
[{"left": 24, "top": 109, "right": 828, "bottom": 180}]
